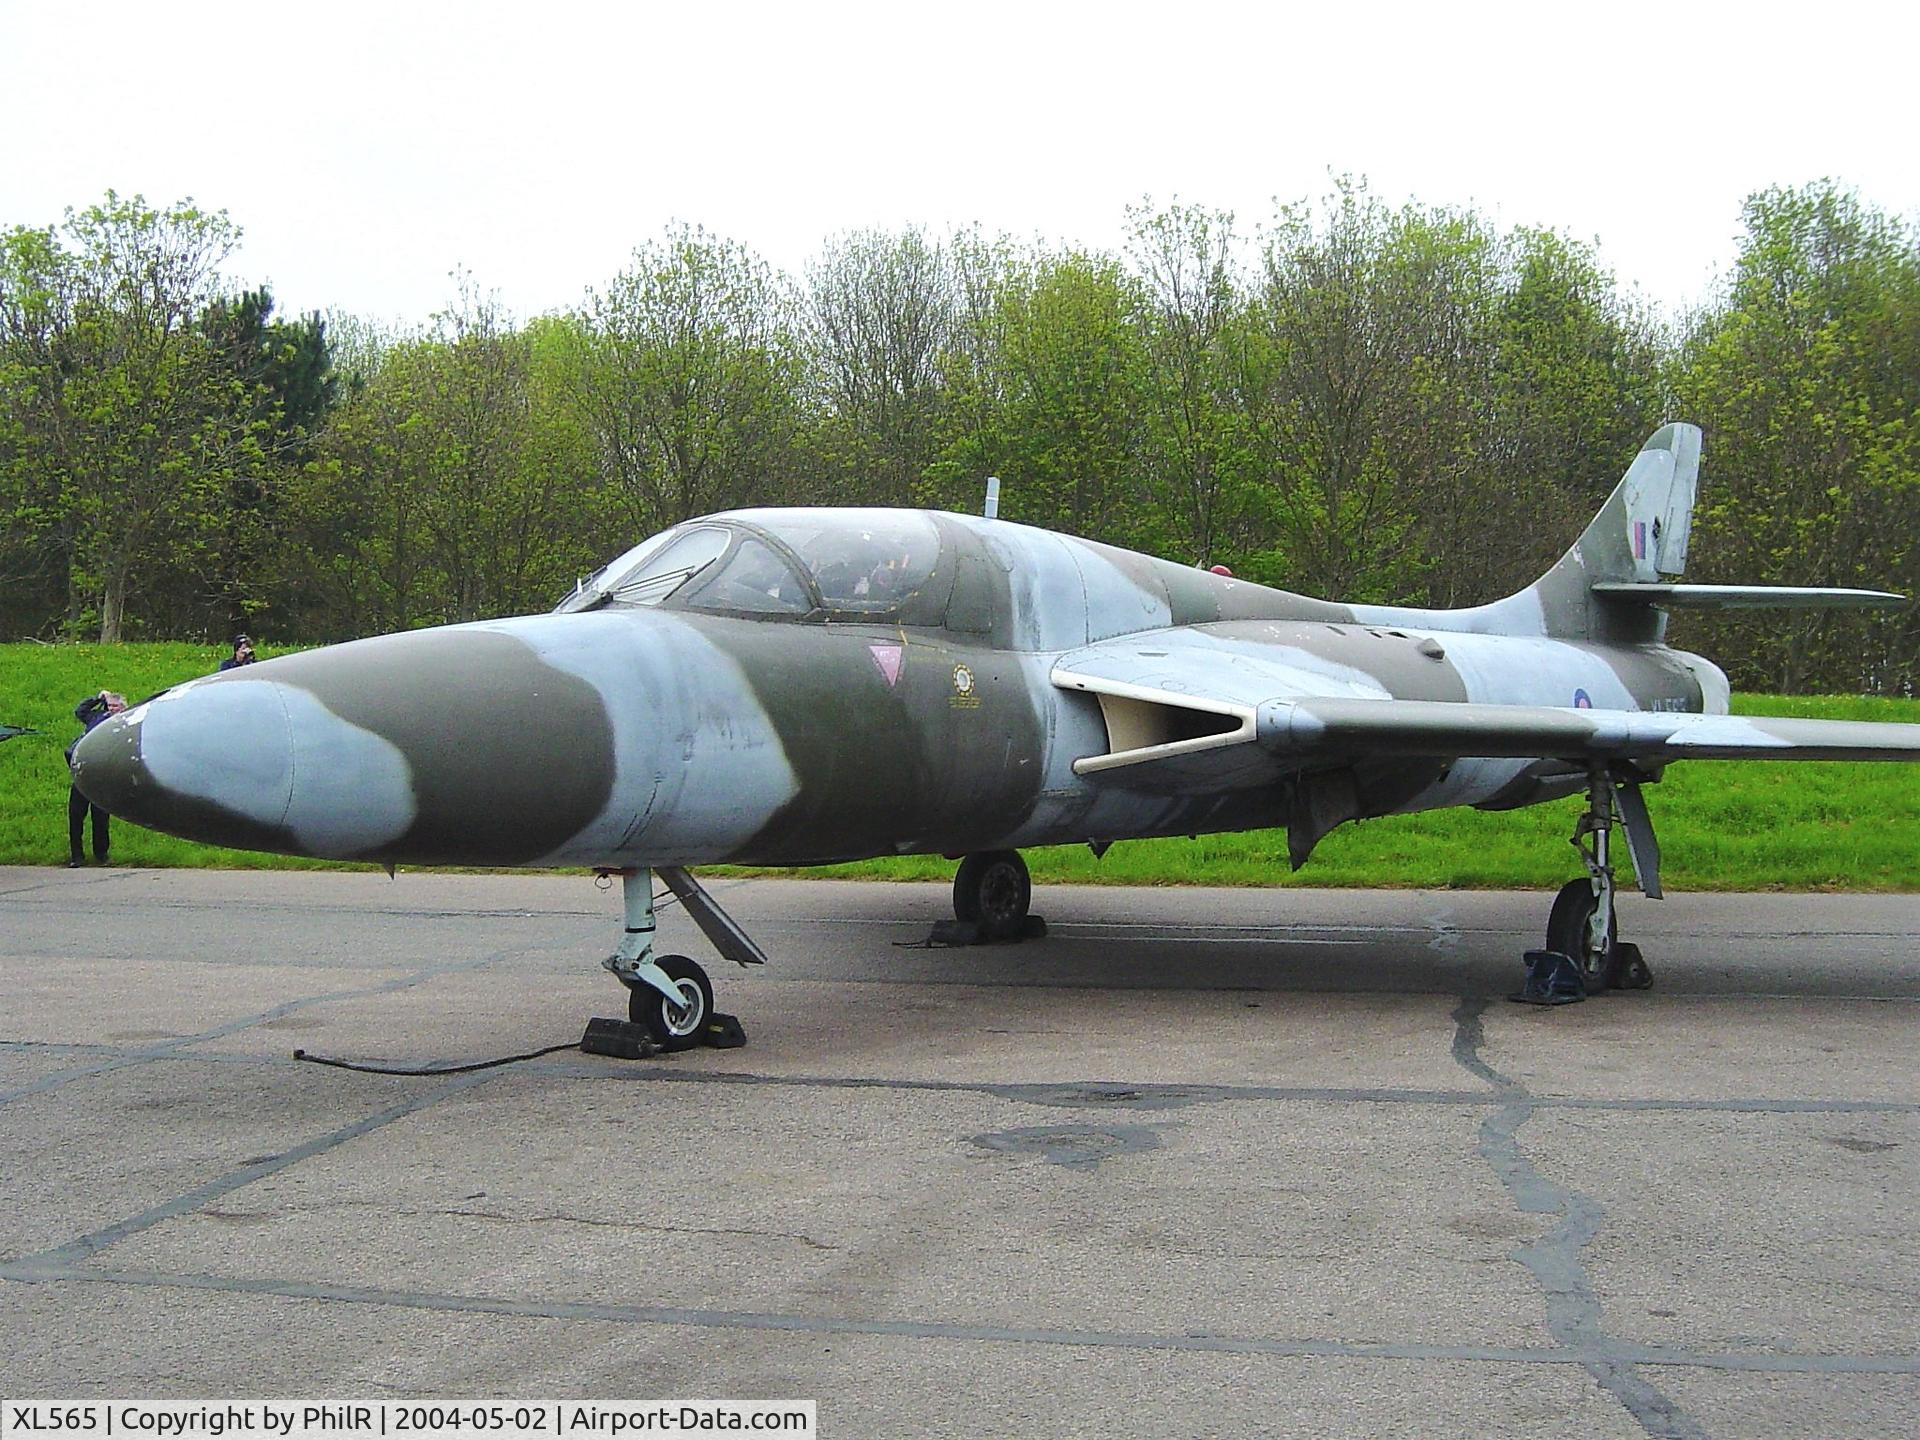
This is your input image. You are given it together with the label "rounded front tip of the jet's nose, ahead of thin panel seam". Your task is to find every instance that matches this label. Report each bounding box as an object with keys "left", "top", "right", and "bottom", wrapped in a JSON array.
[{"left": 73, "top": 682, "right": 294, "bottom": 849}]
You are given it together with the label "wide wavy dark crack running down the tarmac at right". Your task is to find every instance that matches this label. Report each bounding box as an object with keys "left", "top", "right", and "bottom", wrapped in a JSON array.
[{"left": 1453, "top": 995, "right": 1707, "bottom": 1440}]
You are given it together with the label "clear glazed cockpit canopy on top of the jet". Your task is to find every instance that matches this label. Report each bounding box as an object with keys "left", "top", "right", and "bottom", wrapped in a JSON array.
[{"left": 555, "top": 509, "right": 941, "bottom": 620}]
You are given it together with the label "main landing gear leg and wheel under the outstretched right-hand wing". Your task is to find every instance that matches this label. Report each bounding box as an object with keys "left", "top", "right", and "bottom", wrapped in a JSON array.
[{"left": 1523, "top": 766, "right": 1661, "bottom": 998}]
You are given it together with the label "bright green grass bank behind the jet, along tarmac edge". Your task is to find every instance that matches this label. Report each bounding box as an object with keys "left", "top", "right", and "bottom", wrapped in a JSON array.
[{"left": 0, "top": 643, "right": 1920, "bottom": 891}]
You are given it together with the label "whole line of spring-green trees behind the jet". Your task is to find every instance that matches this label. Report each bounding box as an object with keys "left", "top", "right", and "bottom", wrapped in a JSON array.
[{"left": 0, "top": 182, "right": 1920, "bottom": 693}]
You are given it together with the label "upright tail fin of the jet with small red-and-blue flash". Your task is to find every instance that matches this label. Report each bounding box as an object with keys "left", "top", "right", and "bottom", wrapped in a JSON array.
[{"left": 1515, "top": 424, "right": 1699, "bottom": 639}]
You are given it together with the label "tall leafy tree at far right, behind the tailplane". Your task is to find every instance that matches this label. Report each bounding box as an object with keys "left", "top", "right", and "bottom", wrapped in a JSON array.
[{"left": 1674, "top": 182, "right": 1920, "bottom": 693}]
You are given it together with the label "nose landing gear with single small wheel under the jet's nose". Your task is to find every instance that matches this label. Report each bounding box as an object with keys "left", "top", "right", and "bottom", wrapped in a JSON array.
[{"left": 601, "top": 866, "right": 766, "bottom": 1050}]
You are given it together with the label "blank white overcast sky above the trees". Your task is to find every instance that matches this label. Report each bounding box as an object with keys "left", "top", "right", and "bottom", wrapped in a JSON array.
[{"left": 0, "top": 0, "right": 1920, "bottom": 323}]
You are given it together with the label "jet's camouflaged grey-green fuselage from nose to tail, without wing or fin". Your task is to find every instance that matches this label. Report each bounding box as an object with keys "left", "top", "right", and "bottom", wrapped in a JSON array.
[{"left": 75, "top": 511, "right": 1724, "bottom": 868}]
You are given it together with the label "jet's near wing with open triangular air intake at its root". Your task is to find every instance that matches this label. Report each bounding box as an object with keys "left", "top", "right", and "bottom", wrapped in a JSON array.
[{"left": 1052, "top": 632, "right": 1920, "bottom": 789}]
